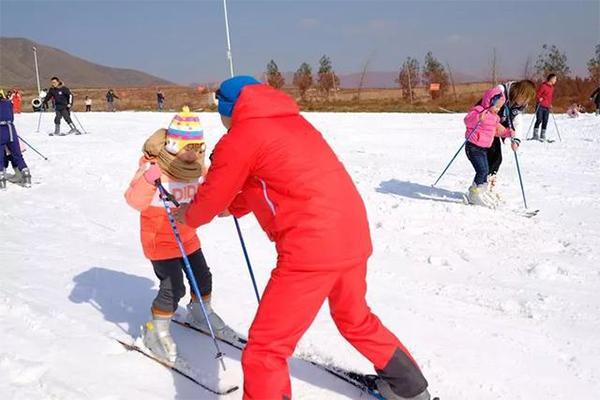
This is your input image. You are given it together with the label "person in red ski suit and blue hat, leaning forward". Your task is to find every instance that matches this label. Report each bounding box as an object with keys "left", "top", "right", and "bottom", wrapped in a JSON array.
[{"left": 177, "top": 76, "right": 430, "bottom": 400}]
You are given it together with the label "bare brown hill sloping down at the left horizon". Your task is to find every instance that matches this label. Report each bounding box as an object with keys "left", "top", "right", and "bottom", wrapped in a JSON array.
[{"left": 0, "top": 37, "right": 174, "bottom": 88}]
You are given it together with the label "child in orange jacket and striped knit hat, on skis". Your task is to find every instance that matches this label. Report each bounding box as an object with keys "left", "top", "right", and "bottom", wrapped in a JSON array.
[{"left": 125, "top": 107, "right": 239, "bottom": 362}]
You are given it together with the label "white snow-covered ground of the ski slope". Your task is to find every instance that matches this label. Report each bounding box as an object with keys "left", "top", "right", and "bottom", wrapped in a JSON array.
[{"left": 0, "top": 112, "right": 600, "bottom": 400}]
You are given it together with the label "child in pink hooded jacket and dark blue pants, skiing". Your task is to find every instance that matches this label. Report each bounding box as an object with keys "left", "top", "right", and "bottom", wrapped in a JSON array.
[{"left": 464, "top": 87, "right": 515, "bottom": 208}]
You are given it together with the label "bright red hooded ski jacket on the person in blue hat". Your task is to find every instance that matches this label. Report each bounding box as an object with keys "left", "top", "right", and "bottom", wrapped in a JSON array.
[{"left": 186, "top": 84, "right": 372, "bottom": 269}]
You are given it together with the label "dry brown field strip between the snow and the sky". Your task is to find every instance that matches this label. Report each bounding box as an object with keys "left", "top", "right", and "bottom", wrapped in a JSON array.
[{"left": 16, "top": 80, "right": 593, "bottom": 112}]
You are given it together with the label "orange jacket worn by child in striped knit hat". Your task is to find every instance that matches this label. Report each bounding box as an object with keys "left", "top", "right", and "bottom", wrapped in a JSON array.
[{"left": 125, "top": 157, "right": 204, "bottom": 260}]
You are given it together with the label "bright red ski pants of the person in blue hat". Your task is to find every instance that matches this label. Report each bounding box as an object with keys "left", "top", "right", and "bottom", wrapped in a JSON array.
[{"left": 242, "top": 261, "right": 414, "bottom": 400}]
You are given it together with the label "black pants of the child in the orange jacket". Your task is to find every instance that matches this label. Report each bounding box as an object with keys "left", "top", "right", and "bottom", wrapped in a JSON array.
[{"left": 151, "top": 249, "right": 212, "bottom": 314}]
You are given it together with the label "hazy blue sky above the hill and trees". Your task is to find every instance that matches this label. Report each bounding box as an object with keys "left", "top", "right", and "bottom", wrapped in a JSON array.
[{"left": 0, "top": 0, "right": 600, "bottom": 83}]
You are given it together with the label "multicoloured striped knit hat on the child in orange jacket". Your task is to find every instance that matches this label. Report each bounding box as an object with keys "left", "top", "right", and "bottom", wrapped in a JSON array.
[{"left": 165, "top": 107, "right": 204, "bottom": 154}]
